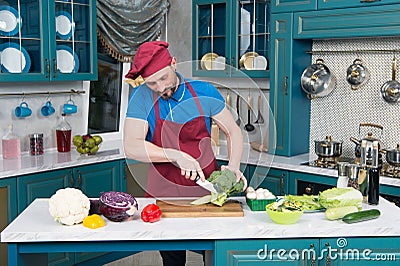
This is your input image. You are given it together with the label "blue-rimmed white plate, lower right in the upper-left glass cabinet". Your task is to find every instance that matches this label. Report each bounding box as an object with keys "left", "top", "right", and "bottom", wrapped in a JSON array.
[{"left": 57, "top": 45, "right": 79, "bottom": 73}]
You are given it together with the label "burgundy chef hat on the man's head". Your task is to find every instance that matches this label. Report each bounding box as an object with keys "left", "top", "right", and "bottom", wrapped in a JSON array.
[{"left": 125, "top": 41, "right": 172, "bottom": 79}]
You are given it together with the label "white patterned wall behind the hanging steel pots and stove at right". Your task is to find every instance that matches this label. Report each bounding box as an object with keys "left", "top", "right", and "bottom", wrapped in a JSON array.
[{"left": 310, "top": 37, "right": 400, "bottom": 159}]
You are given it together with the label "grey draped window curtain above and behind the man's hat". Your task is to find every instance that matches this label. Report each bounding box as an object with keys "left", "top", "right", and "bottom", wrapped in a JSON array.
[{"left": 96, "top": 0, "right": 169, "bottom": 62}]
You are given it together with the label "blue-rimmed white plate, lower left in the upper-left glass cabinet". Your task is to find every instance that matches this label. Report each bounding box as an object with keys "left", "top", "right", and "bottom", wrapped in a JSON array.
[{"left": 0, "top": 42, "right": 31, "bottom": 73}]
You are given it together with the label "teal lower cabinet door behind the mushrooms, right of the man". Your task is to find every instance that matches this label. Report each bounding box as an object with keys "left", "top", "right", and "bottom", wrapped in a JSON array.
[{"left": 249, "top": 166, "right": 289, "bottom": 196}]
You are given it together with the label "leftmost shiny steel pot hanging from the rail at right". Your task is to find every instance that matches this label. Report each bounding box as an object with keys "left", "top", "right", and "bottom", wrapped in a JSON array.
[{"left": 300, "top": 59, "right": 336, "bottom": 99}]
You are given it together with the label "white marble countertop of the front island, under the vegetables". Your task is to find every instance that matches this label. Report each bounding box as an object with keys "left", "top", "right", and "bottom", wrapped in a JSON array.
[{"left": 1, "top": 197, "right": 400, "bottom": 242}]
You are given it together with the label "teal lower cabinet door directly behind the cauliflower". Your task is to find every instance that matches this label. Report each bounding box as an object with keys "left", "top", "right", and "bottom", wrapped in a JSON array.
[{"left": 17, "top": 169, "right": 72, "bottom": 213}]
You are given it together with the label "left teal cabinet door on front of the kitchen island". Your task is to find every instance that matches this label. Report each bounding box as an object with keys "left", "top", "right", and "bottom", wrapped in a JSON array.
[{"left": 214, "top": 239, "right": 319, "bottom": 266}]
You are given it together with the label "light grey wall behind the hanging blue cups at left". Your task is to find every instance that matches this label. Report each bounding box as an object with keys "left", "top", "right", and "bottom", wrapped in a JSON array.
[{"left": 0, "top": 82, "right": 89, "bottom": 155}]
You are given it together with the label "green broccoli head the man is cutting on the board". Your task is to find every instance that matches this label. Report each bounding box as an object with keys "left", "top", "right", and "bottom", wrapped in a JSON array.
[{"left": 193, "top": 169, "right": 244, "bottom": 206}]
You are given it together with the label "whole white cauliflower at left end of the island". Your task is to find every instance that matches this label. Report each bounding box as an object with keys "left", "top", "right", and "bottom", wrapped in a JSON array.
[{"left": 49, "top": 188, "right": 90, "bottom": 225}]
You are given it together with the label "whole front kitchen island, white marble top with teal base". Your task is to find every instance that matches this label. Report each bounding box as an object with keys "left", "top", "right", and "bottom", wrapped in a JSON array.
[{"left": 1, "top": 197, "right": 400, "bottom": 266}]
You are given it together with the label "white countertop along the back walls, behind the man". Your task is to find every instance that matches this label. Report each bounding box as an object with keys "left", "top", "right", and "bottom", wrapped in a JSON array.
[{"left": 0, "top": 140, "right": 400, "bottom": 187}]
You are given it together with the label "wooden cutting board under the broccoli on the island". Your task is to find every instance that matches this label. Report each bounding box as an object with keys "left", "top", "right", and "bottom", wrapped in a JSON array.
[{"left": 156, "top": 199, "right": 244, "bottom": 218}]
